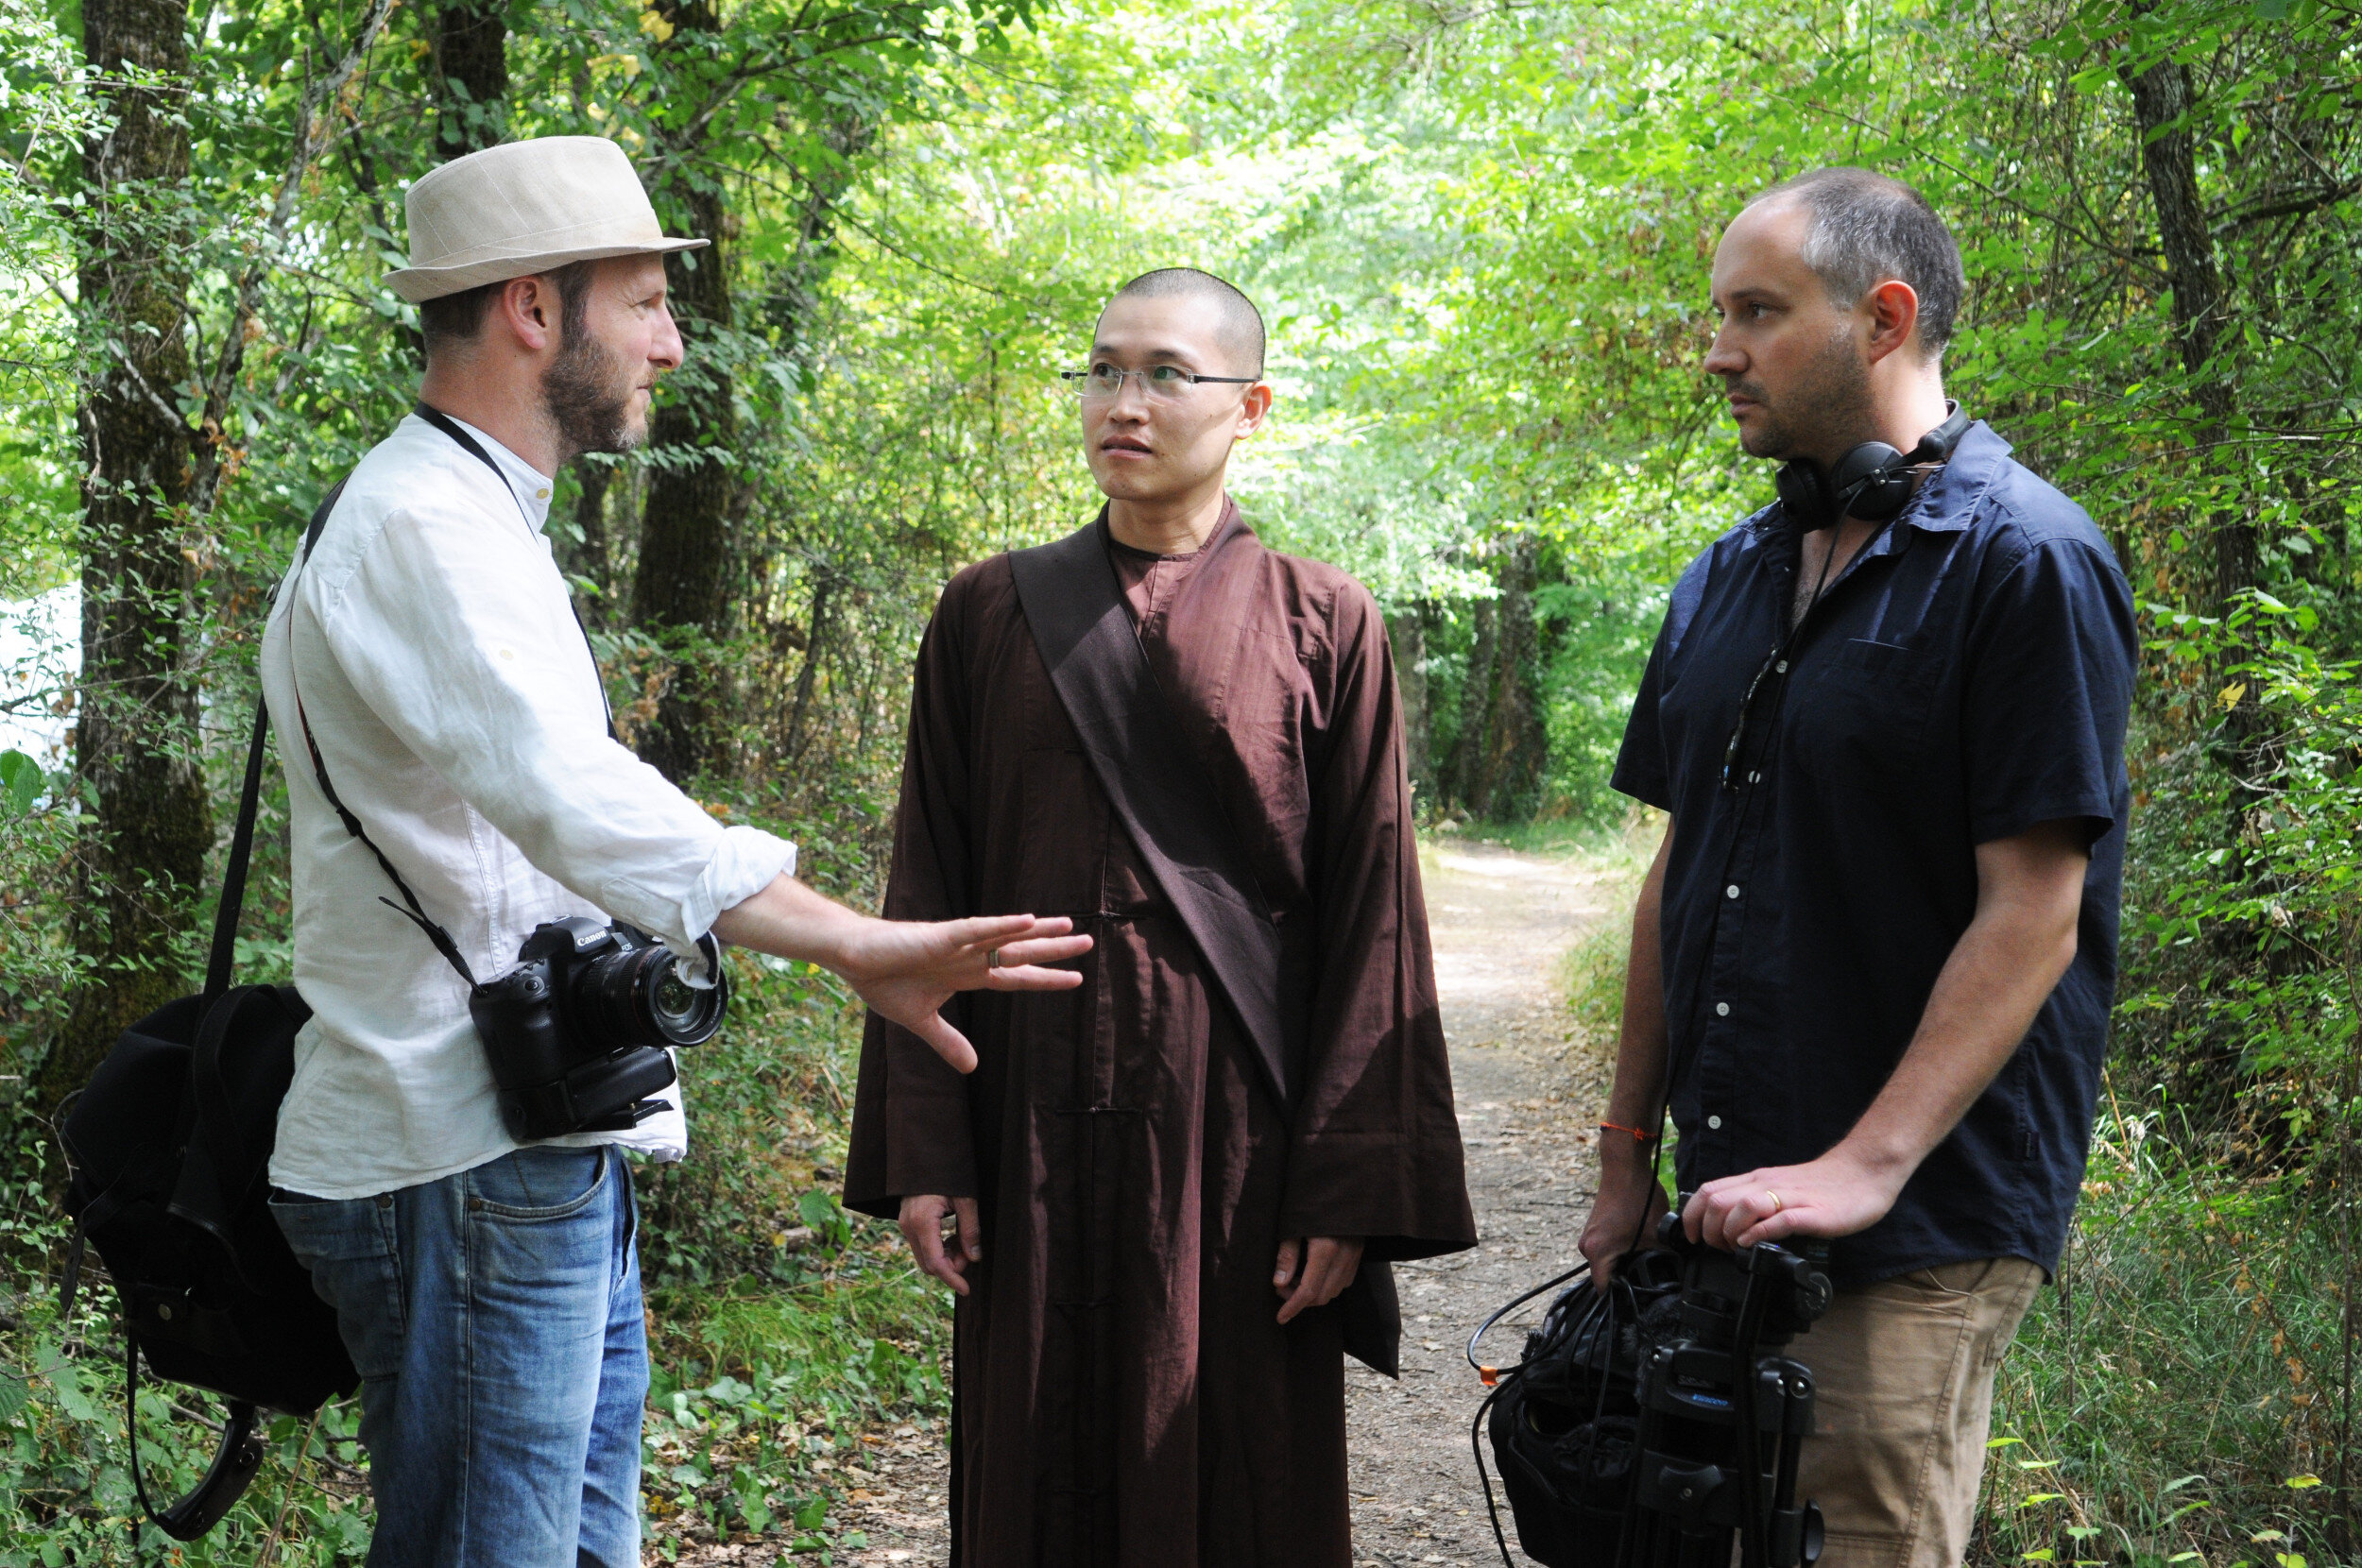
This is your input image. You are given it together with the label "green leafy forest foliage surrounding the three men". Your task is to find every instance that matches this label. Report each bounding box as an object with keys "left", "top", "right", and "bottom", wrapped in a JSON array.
[{"left": 0, "top": 0, "right": 2362, "bottom": 1568}]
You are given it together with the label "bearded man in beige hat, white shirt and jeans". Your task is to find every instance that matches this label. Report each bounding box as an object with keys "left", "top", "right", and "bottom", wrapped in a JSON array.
[{"left": 263, "top": 137, "right": 1089, "bottom": 1568}]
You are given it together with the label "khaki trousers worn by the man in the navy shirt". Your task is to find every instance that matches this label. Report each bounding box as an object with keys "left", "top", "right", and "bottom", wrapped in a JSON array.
[{"left": 1789, "top": 1259, "right": 2044, "bottom": 1568}]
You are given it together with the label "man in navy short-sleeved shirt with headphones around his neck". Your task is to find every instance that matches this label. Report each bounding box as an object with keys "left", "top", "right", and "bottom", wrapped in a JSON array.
[{"left": 1583, "top": 168, "right": 2138, "bottom": 1568}]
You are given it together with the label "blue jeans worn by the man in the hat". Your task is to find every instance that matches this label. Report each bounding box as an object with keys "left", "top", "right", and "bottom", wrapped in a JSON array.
[{"left": 272, "top": 1148, "right": 647, "bottom": 1568}]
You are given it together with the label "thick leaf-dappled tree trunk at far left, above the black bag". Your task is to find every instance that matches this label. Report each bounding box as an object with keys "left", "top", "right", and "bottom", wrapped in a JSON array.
[{"left": 36, "top": 0, "right": 213, "bottom": 1105}]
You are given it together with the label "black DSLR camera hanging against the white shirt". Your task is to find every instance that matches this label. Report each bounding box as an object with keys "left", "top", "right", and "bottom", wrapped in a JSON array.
[{"left": 468, "top": 914, "right": 730, "bottom": 1143}]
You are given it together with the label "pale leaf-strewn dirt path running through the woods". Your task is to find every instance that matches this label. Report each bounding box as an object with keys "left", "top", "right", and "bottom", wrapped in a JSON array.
[{"left": 831, "top": 839, "right": 1611, "bottom": 1568}]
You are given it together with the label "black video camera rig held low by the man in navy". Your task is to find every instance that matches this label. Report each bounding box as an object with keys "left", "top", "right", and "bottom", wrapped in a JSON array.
[{"left": 1469, "top": 1212, "right": 1831, "bottom": 1568}]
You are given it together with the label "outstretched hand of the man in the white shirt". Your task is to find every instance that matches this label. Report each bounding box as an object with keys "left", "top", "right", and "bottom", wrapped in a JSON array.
[{"left": 831, "top": 914, "right": 1091, "bottom": 1072}]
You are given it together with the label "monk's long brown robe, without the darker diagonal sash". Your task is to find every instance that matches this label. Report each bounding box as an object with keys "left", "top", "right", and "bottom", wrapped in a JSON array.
[{"left": 846, "top": 508, "right": 1477, "bottom": 1568}]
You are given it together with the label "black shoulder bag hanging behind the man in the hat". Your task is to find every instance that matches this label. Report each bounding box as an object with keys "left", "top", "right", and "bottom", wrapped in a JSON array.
[{"left": 57, "top": 485, "right": 362, "bottom": 1540}]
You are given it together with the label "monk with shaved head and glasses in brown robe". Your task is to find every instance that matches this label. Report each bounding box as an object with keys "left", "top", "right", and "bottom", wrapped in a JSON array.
[{"left": 846, "top": 267, "right": 1477, "bottom": 1568}]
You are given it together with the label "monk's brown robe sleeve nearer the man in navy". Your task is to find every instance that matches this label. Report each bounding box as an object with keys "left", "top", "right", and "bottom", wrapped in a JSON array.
[{"left": 1280, "top": 581, "right": 1477, "bottom": 1261}]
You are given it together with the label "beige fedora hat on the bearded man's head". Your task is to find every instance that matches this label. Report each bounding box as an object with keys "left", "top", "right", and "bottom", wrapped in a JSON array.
[{"left": 385, "top": 137, "right": 711, "bottom": 305}]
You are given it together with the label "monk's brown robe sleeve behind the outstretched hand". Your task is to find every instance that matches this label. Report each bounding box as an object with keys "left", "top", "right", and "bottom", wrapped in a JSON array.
[{"left": 846, "top": 574, "right": 978, "bottom": 1219}]
